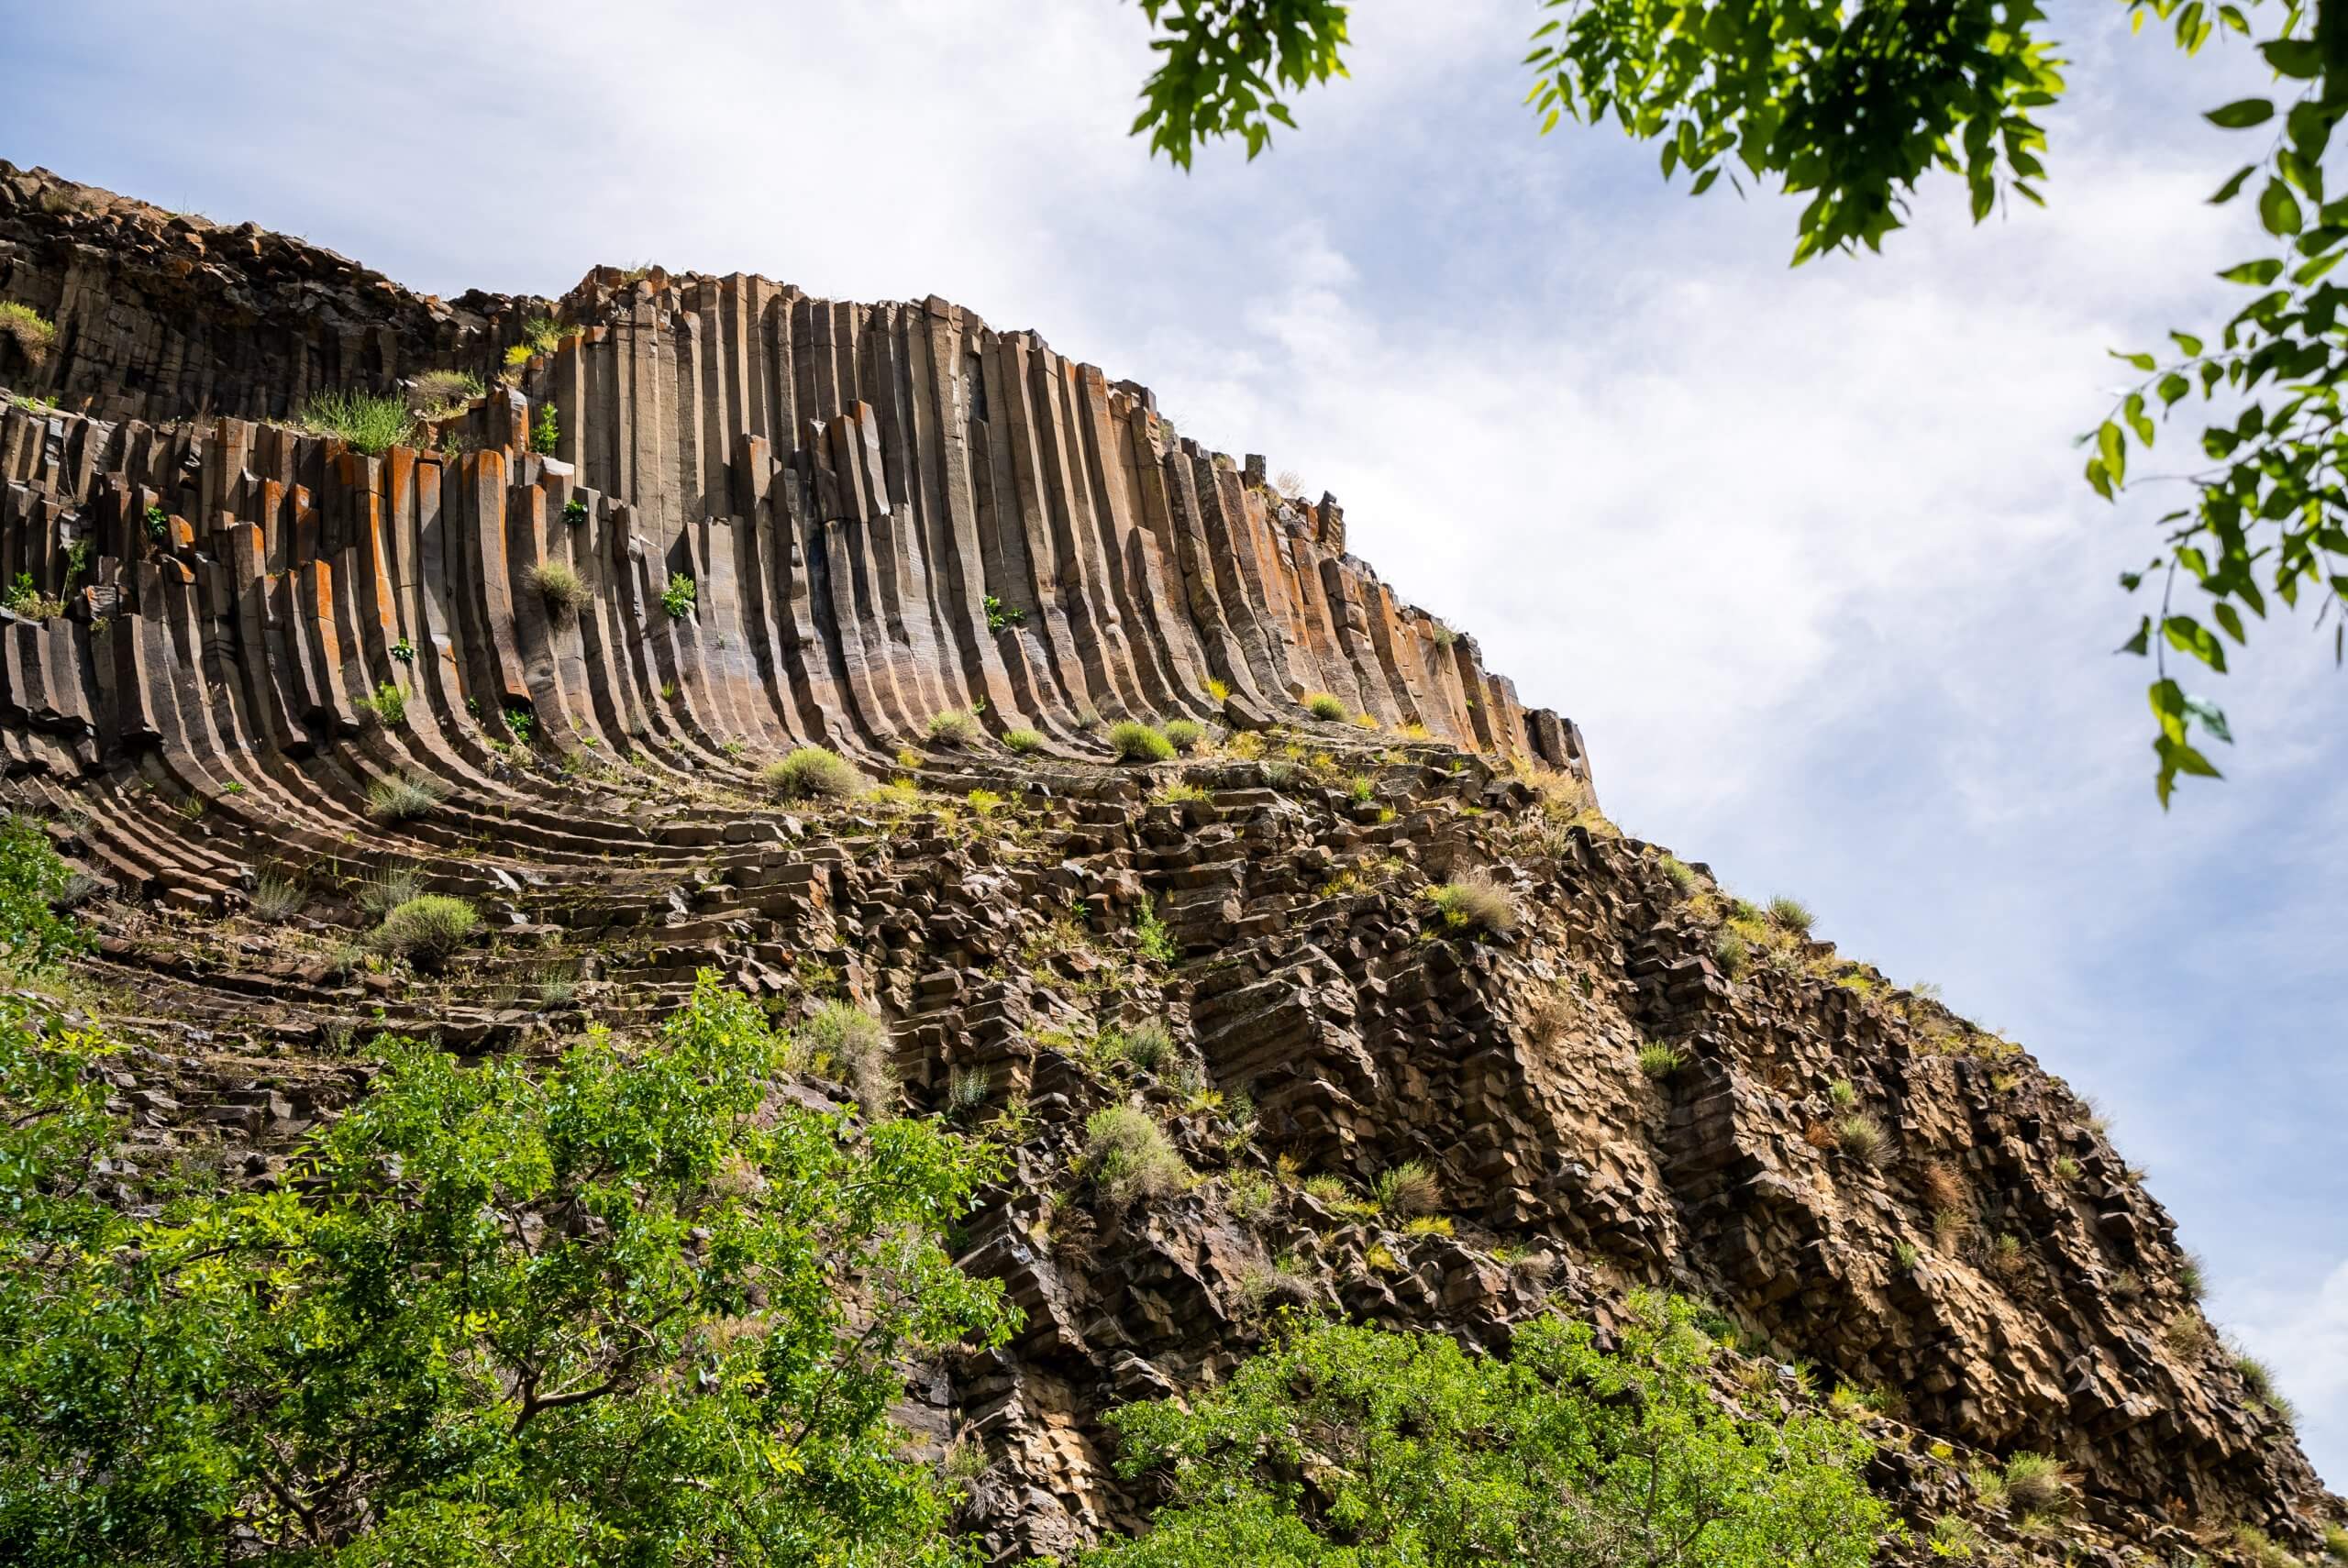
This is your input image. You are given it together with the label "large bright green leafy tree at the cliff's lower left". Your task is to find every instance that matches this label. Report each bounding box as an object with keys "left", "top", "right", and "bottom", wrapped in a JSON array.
[{"left": 0, "top": 974, "right": 1014, "bottom": 1568}]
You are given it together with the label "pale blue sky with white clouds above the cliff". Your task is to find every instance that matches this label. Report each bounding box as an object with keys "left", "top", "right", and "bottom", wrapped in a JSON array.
[{"left": 0, "top": 0, "right": 2348, "bottom": 1485}]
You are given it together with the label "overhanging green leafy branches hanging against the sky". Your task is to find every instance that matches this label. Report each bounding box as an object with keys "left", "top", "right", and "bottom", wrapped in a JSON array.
[{"left": 1134, "top": 0, "right": 2348, "bottom": 805}]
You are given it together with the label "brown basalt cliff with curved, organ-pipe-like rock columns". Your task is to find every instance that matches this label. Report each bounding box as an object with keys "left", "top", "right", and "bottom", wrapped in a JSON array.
[{"left": 0, "top": 164, "right": 2339, "bottom": 1563}]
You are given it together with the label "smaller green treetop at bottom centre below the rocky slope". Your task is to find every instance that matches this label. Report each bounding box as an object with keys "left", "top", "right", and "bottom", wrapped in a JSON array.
[{"left": 1087, "top": 1296, "right": 1895, "bottom": 1568}]
